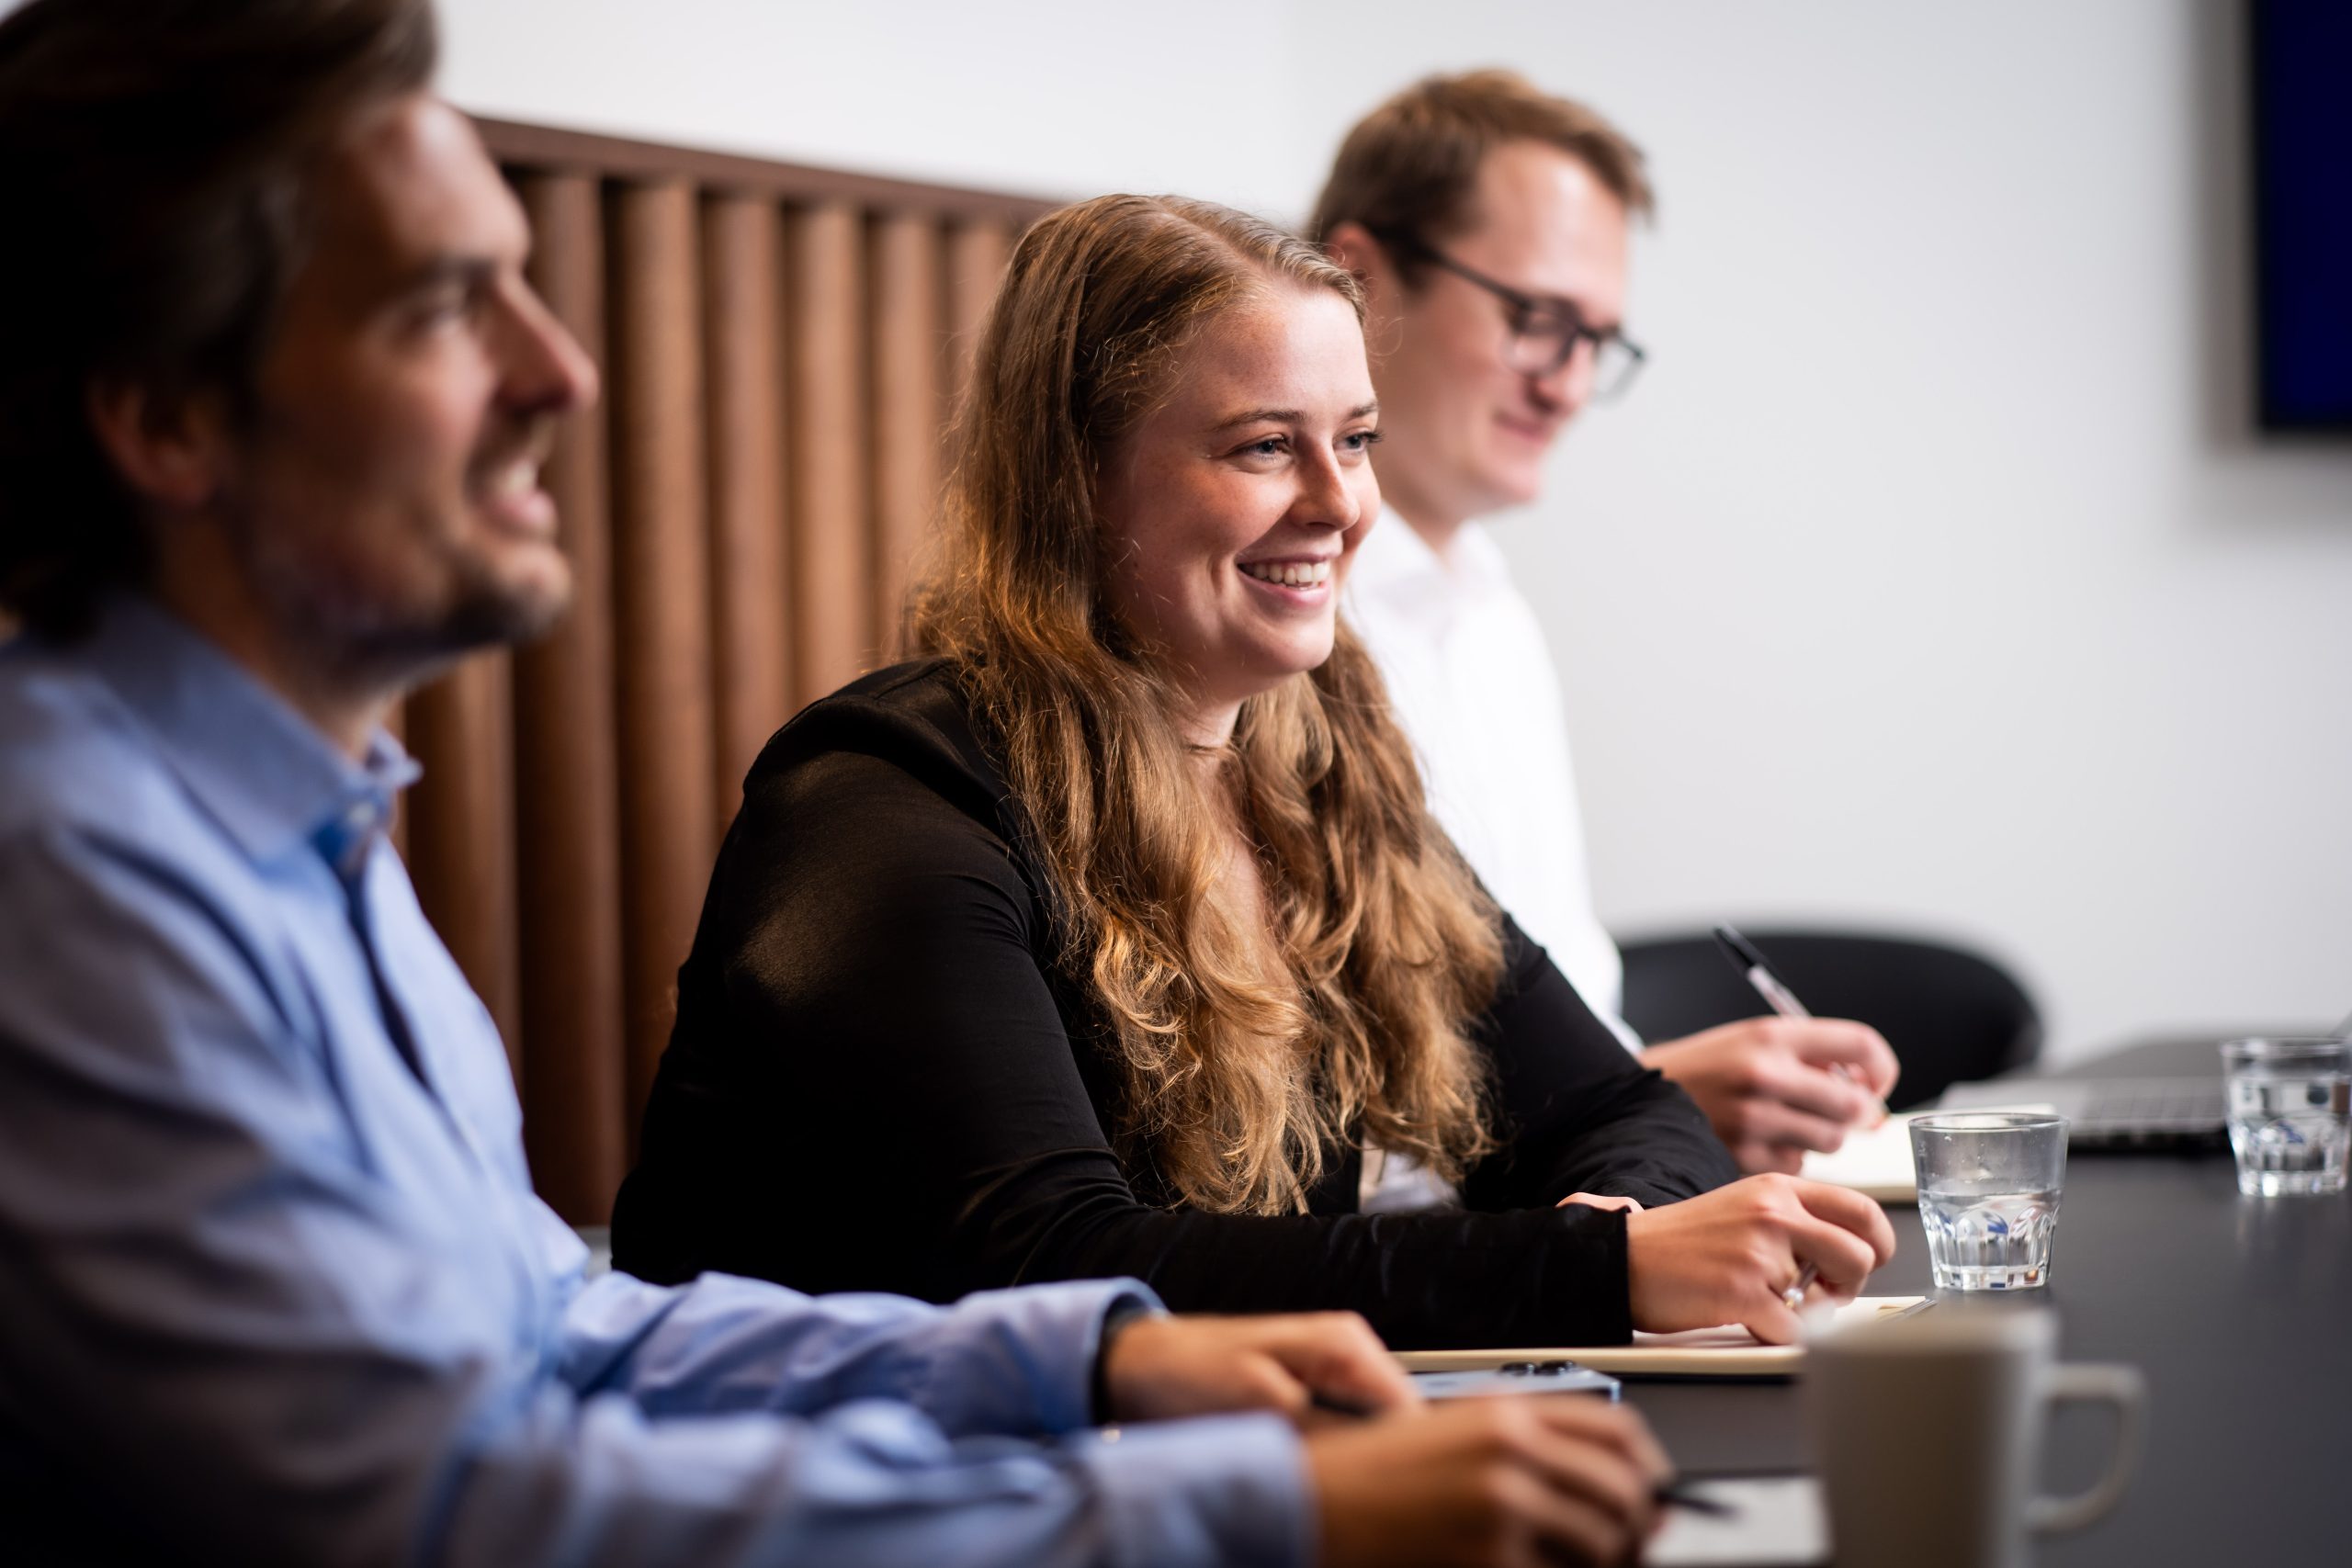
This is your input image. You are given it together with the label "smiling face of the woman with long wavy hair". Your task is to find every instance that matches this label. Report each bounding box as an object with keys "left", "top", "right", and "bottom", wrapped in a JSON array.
[{"left": 1096, "top": 280, "right": 1381, "bottom": 743}]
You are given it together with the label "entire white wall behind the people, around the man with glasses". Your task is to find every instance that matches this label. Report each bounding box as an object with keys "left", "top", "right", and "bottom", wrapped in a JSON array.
[{"left": 445, "top": 0, "right": 2352, "bottom": 1054}]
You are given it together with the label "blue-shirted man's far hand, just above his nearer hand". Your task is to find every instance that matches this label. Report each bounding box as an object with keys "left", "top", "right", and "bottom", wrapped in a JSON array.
[{"left": 1103, "top": 1312, "right": 1420, "bottom": 1425}]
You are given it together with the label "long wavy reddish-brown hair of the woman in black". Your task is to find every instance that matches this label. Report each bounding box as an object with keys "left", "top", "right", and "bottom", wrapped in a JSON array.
[{"left": 910, "top": 195, "right": 1500, "bottom": 1213}]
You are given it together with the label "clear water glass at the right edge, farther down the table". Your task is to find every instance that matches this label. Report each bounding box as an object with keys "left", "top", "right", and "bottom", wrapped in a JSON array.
[{"left": 2221, "top": 1039, "right": 2352, "bottom": 1197}]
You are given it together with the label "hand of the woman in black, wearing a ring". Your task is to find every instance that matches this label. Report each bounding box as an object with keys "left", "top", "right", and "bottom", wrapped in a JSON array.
[{"left": 1625, "top": 1176, "right": 1895, "bottom": 1345}]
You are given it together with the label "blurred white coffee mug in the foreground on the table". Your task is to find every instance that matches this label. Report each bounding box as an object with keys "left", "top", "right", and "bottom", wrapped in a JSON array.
[{"left": 1804, "top": 1303, "right": 2147, "bottom": 1568}]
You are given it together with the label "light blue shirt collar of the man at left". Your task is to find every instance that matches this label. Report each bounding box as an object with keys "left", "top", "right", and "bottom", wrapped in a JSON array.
[{"left": 73, "top": 594, "right": 419, "bottom": 877}]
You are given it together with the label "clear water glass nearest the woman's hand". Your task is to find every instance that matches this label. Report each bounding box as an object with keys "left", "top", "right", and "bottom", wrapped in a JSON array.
[{"left": 1910, "top": 1110, "right": 2065, "bottom": 1291}]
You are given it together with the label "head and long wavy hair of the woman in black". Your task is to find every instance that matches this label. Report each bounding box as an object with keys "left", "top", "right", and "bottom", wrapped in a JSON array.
[{"left": 915, "top": 197, "right": 1500, "bottom": 1213}]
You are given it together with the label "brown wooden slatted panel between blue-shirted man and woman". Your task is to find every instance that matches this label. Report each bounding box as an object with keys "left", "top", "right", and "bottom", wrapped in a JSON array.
[{"left": 398, "top": 122, "right": 1046, "bottom": 1224}]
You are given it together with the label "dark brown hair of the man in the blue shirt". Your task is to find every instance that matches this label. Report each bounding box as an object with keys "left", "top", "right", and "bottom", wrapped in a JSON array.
[{"left": 0, "top": 0, "right": 440, "bottom": 637}]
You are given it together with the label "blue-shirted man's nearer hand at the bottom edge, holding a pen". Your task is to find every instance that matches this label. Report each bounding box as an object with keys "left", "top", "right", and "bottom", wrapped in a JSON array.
[{"left": 1307, "top": 1394, "right": 1672, "bottom": 1568}]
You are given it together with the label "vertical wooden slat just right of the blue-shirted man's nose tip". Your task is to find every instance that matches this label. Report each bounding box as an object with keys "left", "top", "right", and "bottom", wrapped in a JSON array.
[{"left": 609, "top": 184, "right": 718, "bottom": 1152}]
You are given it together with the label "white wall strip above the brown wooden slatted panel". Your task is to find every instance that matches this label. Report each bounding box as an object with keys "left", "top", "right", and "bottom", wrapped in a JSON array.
[{"left": 440, "top": 0, "right": 1319, "bottom": 207}]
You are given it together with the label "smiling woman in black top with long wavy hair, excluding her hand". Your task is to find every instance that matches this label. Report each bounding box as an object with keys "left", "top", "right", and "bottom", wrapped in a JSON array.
[{"left": 614, "top": 197, "right": 1731, "bottom": 1345}]
